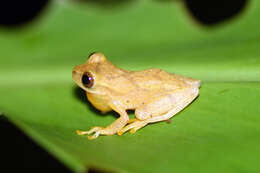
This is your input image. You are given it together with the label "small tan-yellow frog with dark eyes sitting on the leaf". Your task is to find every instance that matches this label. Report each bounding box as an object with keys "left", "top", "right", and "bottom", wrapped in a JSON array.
[{"left": 72, "top": 52, "right": 201, "bottom": 140}]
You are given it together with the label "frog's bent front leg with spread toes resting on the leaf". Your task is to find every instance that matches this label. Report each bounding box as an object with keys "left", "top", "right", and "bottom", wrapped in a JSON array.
[{"left": 77, "top": 103, "right": 129, "bottom": 139}]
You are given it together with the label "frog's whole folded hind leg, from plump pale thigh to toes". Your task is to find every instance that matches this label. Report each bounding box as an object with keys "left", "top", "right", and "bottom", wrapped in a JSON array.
[{"left": 118, "top": 88, "right": 199, "bottom": 135}]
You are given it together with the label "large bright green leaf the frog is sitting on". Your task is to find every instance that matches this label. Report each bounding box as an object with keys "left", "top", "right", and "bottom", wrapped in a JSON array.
[{"left": 0, "top": 1, "right": 260, "bottom": 172}]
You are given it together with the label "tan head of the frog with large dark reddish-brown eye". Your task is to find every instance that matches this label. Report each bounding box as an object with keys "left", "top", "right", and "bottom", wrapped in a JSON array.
[{"left": 72, "top": 53, "right": 123, "bottom": 94}]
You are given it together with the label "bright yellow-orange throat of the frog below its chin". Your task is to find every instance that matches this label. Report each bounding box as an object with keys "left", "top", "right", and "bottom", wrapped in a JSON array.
[{"left": 86, "top": 93, "right": 112, "bottom": 113}]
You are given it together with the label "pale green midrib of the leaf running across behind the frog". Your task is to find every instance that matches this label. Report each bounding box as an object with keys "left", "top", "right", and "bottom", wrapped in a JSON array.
[{"left": 0, "top": 64, "right": 260, "bottom": 87}]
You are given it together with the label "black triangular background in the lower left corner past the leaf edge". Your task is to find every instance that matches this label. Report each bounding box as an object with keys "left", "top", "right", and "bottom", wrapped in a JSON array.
[{"left": 0, "top": 116, "right": 70, "bottom": 173}]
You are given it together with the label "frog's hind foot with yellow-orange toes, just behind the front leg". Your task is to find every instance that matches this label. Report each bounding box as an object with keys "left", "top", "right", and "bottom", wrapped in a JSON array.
[{"left": 117, "top": 119, "right": 149, "bottom": 135}]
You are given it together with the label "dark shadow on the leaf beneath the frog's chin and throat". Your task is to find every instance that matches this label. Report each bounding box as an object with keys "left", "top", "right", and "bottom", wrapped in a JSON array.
[{"left": 73, "top": 86, "right": 119, "bottom": 118}]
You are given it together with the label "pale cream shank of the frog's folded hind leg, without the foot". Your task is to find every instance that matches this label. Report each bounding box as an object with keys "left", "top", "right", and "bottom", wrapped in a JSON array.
[{"left": 148, "top": 88, "right": 199, "bottom": 123}]
